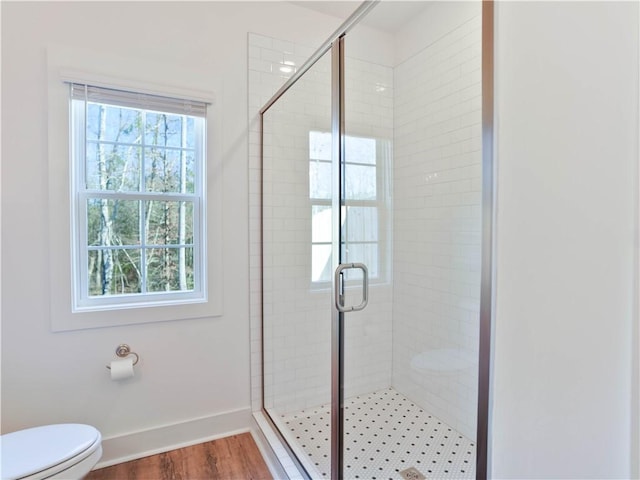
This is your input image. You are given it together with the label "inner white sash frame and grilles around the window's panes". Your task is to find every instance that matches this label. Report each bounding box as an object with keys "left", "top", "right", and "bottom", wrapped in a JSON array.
[{"left": 69, "top": 84, "right": 207, "bottom": 312}]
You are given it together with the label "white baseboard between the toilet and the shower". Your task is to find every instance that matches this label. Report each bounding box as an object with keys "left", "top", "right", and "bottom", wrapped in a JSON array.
[{"left": 94, "top": 408, "right": 255, "bottom": 470}]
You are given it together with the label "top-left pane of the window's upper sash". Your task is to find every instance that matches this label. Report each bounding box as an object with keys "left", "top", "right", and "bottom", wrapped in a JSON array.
[{"left": 87, "top": 102, "right": 142, "bottom": 143}]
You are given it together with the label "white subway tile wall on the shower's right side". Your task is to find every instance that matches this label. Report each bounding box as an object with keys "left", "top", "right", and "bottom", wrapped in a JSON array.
[{"left": 392, "top": 16, "right": 482, "bottom": 440}]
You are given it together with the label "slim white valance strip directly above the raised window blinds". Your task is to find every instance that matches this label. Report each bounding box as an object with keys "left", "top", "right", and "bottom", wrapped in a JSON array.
[{"left": 58, "top": 68, "right": 215, "bottom": 104}]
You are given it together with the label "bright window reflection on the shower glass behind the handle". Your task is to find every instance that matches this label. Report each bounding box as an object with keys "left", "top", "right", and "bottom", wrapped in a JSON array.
[{"left": 309, "top": 131, "right": 389, "bottom": 284}]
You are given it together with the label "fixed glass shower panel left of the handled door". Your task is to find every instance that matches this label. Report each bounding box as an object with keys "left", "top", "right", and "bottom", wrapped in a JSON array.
[{"left": 262, "top": 47, "right": 333, "bottom": 478}]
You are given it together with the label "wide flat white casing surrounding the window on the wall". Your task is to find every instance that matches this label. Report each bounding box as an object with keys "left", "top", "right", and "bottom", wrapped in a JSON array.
[{"left": 43, "top": 45, "right": 224, "bottom": 332}]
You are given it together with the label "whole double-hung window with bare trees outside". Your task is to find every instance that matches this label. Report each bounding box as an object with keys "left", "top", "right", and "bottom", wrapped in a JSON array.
[{"left": 70, "top": 84, "right": 206, "bottom": 310}]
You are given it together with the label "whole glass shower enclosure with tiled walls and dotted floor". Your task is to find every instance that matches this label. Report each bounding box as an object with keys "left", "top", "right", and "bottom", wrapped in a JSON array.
[{"left": 254, "top": 2, "right": 491, "bottom": 479}]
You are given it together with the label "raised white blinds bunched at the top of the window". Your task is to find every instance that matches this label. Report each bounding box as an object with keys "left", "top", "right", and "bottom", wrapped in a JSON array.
[{"left": 71, "top": 83, "right": 207, "bottom": 117}]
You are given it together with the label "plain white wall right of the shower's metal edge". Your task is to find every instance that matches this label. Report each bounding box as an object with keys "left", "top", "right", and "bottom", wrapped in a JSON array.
[{"left": 492, "top": 2, "right": 639, "bottom": 478}]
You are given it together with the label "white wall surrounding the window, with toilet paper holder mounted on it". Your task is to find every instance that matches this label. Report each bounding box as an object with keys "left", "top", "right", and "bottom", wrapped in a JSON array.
[{"left": 2, "top": 2, "right": 339, "bottom": 464}]
